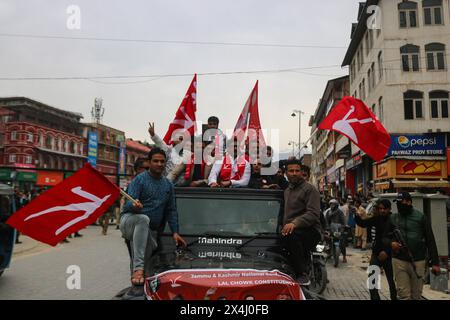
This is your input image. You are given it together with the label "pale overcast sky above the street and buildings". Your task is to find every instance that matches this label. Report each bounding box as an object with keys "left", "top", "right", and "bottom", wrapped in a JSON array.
[{"left": 0, "top": 0, "right": 358, "bottom": 150}]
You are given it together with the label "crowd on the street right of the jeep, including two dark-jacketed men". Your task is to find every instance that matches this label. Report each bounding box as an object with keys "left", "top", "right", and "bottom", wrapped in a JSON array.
[{"left": 322, "top": 192, "right": 440, "bottom": 300}]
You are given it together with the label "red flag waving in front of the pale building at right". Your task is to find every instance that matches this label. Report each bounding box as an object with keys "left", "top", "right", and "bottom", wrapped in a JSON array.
[{"left": 319, "top": 97, "right": 391, "bottom": 161}]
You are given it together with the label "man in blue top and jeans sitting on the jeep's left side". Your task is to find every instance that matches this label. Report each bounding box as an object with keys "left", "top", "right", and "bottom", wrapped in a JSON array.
[{"left": 120, "top": 148, "right": 186, "bottom": 285}]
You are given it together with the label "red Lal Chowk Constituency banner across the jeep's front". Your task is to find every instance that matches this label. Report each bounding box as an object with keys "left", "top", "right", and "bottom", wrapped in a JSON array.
[{"left": 145, "top": 269, "right": 305, "bottom": 300}]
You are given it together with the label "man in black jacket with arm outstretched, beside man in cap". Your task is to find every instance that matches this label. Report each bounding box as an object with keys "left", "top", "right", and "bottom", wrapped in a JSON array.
[{"left": 355, "top": 199, "right": 397, "bottom": 300}]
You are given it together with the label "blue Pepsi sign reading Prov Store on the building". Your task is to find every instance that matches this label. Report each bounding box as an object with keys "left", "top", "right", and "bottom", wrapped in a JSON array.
[{"left": 388, "top": 134, "right": 446, "bottom": 156}]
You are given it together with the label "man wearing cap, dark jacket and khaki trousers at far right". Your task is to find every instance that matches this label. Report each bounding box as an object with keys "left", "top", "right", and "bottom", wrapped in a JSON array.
[{"left": 383, "top": 192, "right": 440, "bottom": 300}]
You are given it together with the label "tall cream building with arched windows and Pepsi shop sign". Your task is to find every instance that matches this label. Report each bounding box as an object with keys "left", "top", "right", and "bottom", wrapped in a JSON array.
[{"left": 342, "top": 0, "right": 450, "bottom": 192}]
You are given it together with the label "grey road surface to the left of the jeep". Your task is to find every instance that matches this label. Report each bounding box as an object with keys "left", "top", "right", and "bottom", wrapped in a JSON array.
[{"left": 0, "top": 226, "right": 130, "bottom": 300}]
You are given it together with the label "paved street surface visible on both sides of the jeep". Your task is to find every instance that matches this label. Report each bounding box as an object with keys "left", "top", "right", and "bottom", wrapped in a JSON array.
[{"left": 0, "top": 225, "right": 446, "bottom": 300}]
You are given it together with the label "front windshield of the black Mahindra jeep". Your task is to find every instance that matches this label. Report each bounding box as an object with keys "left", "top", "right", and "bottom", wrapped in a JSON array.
[{"left": 172, "top": 192, "right": 281, "bottom": 236}]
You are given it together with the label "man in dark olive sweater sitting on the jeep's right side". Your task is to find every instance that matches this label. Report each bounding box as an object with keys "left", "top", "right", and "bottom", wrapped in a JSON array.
[{"left": 281, "top": 159, "right": 321, "bottom": 286}]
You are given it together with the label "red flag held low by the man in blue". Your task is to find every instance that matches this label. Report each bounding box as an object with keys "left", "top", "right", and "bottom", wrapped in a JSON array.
[{"left": 6, "top": 163, "right": 120, "bottom": 246}]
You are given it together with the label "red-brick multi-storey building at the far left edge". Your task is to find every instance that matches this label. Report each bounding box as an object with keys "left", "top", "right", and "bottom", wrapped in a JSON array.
[{"left": 0, "top": 97, "right": 86, "bottom": 188}]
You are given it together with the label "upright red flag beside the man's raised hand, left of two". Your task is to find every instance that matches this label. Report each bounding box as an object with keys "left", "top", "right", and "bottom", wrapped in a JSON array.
[{"left": 164, "top": 74, "right": 197, "bottom": 144}]
